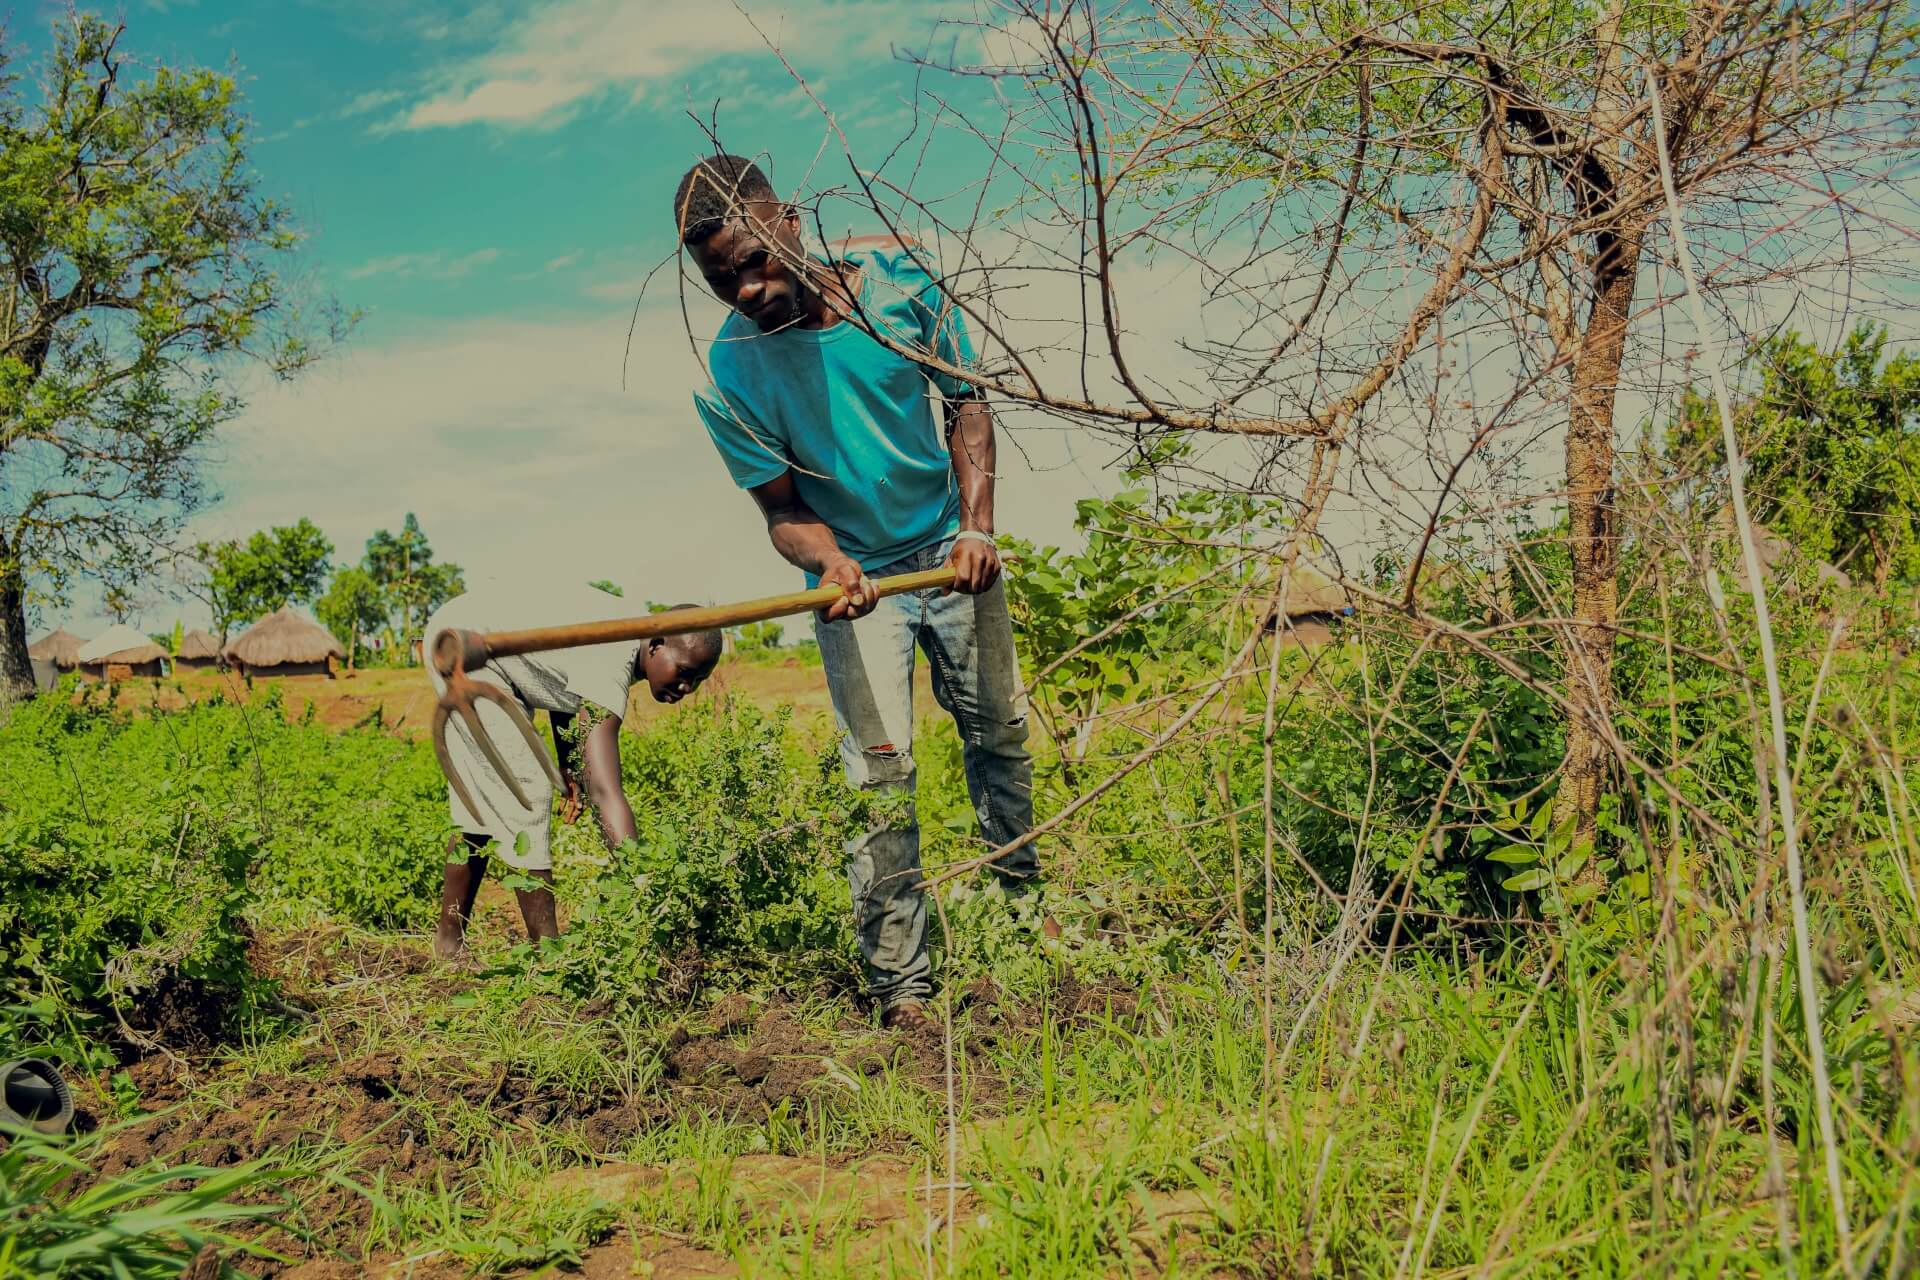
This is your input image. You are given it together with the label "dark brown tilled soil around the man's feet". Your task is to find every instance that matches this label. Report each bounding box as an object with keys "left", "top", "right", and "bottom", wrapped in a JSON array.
[{"left": 83, "top": 931, "right": 1139, "bottom": 1280}]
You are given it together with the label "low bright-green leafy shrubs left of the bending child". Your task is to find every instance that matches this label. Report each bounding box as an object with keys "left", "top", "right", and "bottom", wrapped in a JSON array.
[{"left": 0, "top": 687, "right": 447, "bottom": 1007}]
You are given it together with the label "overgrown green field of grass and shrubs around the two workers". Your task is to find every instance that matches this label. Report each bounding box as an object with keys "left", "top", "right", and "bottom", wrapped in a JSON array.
[{"left": 0, "top": 552, "right": 1920, "bottom": 1276}]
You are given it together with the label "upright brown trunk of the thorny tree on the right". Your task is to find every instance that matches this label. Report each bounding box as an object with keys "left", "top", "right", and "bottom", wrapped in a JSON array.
[{"left": 1553, "top": 234, "right": 1640, "bottom": 867}]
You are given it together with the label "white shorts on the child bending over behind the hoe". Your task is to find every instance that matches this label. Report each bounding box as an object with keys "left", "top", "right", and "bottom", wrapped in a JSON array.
[{"left": 424, "top": 608, "right": 553, "bottom": 871}]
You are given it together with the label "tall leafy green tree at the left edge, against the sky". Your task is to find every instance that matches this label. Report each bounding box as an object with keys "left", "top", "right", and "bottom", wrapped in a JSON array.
[{"left": 0, "top": 13, "right": 346, "bottom": 689}]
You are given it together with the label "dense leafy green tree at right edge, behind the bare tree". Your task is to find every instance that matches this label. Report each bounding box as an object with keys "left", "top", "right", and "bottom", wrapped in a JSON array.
[{"left": 1667, "top": 324, "right": 1920, "bottom": 591}]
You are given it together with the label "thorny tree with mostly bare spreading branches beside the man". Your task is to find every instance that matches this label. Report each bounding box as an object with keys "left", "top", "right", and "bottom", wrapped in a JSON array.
[{"left": 752, "top": 0, "right": 1914, "bottom": 859}]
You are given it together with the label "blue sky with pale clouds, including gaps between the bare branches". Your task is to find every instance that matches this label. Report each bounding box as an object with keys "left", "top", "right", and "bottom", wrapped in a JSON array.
[{"left": 22, "top": 0, "right": 1920, "bottom": 637}]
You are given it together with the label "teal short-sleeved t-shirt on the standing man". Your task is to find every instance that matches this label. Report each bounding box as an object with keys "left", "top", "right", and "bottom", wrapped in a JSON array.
[{"left": 693, "top": 248, "right": 973, "bottom": 570}]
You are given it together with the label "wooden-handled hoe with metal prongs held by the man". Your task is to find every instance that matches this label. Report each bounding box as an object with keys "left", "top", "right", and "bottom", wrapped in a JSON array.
[{"left": 432, "top": 568, "right": 954, "bottom": 810}]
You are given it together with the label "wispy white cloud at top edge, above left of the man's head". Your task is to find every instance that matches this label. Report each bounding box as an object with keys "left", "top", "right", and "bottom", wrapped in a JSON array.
[{"left": 378, "top": 0, "right": 931, "bottom": 130}]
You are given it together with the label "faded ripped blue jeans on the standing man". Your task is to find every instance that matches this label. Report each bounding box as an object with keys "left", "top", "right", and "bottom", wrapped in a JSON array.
[{"left": 814, "top": 539, "right": 1041, "bottom": 1007}]
